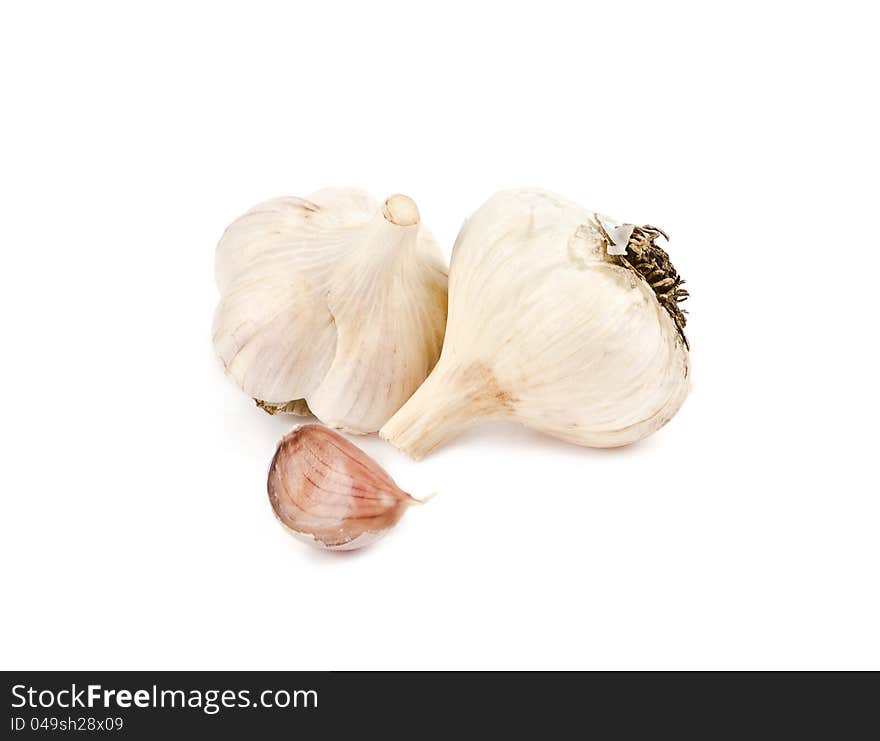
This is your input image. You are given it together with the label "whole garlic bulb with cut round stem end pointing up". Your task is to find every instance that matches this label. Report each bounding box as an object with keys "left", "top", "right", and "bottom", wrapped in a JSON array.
[{"left": 214, "top": 188, "right": 447, "bottom": 433}]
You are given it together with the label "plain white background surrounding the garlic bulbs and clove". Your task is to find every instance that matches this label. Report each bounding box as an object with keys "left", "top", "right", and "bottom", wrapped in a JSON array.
[{"left": 0, "top": 0, "right": 880, "bottom": 669}]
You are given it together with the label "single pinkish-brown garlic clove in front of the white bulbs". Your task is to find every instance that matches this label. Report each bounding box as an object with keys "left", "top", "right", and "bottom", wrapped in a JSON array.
[{"left": 268, "top": 425, "right": 418, "bottom": 550}]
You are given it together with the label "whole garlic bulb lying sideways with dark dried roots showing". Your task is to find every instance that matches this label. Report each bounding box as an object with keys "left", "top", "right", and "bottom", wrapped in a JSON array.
[{"left": 379, "top": 190, "right": 688, "bottom": 459}]
